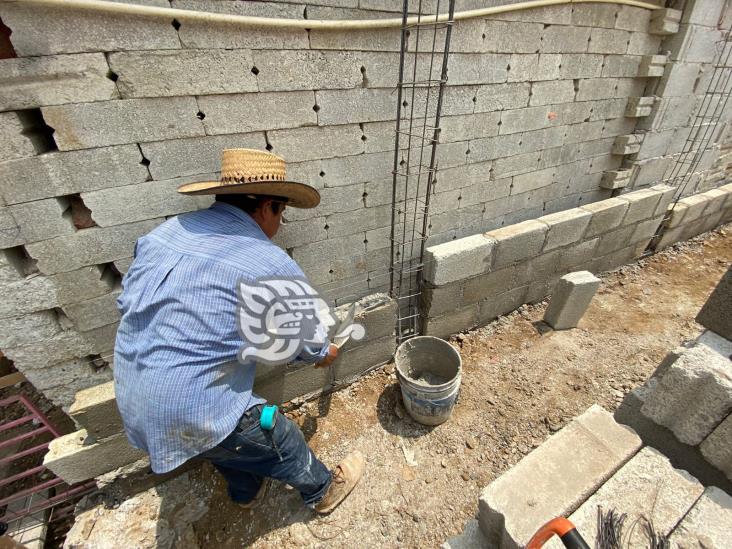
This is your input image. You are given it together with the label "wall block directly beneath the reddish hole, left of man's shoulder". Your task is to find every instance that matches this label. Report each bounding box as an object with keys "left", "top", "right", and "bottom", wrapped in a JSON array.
[{"left": 26, "top": 219, "right": 162, "bottom": 274}]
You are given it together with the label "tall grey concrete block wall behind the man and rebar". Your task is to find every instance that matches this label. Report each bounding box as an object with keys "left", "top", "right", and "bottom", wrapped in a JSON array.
[{"left": 0, "top": 0, "right": 729, "bottom": 405}]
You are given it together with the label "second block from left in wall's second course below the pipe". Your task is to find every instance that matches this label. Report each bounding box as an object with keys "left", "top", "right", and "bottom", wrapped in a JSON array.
[{"left": 109, "top": 49, "right": 258, "bottom": 98}]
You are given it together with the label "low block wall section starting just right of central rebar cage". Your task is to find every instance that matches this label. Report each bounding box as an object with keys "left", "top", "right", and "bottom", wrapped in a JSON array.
[{"left": 423, "top": 185, "right": 674, "bottom": 336}]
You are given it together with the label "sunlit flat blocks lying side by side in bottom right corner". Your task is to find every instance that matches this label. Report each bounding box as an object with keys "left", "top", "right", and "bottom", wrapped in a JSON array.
[{"left": 443, "top": 406, "right": 732, "bottom": 549}]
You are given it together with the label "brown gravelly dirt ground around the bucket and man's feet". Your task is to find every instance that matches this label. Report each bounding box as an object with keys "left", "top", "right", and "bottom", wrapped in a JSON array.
[{"left": 194, "top": 225, "right": 732, "bottom": 548}]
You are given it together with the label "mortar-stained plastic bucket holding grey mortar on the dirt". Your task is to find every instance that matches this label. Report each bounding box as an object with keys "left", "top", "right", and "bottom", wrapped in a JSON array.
[{"left": 394, "top": 336, "right": 462, "bottom": 425}]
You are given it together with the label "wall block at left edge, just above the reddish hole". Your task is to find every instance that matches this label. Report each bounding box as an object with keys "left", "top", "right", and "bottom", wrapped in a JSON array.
[{"left": 0, "top": 145, "right": 149, "bottom": 204}]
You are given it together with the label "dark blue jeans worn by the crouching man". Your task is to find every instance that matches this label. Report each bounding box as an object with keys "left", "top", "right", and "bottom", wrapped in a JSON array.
[{"left": 199, "top": 404, "right": 331, "bottom": 507}]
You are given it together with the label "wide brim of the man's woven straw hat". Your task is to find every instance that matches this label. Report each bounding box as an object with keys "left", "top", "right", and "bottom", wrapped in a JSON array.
[{"left": 178, "top": 181, "right": 320, "bottom": 208}]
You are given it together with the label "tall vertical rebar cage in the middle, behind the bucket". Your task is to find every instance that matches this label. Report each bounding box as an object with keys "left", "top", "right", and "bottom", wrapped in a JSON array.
[{"left": 389, "top": 0, "right": 455, "bottom": 342}]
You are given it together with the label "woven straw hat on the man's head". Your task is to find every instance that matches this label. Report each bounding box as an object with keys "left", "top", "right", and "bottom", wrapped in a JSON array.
[{"left": 178, "top": 149, "right": 320, "bottom": 208}]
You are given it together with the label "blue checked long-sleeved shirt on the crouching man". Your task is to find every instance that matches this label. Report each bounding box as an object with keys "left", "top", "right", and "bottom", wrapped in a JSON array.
[{"left": 114, "top": 202, "right": 328, "bottom": 473}]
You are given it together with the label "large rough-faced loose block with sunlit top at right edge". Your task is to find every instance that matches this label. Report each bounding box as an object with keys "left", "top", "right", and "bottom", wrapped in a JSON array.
[{"left": 641, "top": 344, "right": 732, "bottom": 446}]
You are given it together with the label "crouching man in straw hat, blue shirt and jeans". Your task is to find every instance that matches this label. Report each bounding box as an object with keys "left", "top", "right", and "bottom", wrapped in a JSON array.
[{"left": 114, "top": 149, "right": 364, "bottom": 513}]
